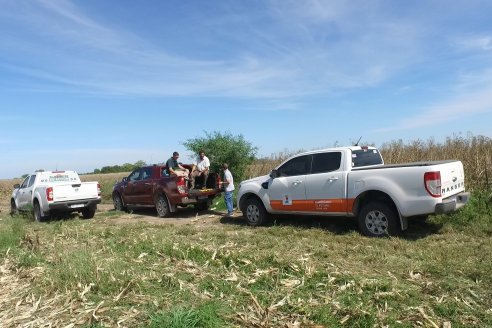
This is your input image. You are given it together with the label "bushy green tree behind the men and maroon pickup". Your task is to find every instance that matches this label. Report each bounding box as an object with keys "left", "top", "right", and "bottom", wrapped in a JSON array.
[{"left": 183, "top": 131, "right": 258, "bottom": 182}]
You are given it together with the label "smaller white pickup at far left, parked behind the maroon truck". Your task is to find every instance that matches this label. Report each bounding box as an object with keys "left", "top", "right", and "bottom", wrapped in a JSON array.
[{"left": 10, "top": 170, "right": 101, "bottom": 221}]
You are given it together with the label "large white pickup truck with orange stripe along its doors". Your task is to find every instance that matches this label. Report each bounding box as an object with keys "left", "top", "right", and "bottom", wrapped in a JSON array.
[{"left": 237, "top": 146, "right": 470, "bottom": 237}]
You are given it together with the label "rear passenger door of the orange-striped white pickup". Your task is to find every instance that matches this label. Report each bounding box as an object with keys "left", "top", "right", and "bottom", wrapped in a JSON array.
[{"left": 306, "top": 151, "right": 351, "bottom": 215}]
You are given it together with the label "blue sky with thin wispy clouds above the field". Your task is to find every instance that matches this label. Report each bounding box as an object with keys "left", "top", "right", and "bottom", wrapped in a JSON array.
[{"left": 0, "top": 0, "right": 492, "bottom": 178}]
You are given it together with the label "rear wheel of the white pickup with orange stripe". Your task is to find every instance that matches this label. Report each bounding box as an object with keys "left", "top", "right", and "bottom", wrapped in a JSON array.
[{"left": 358, "top": 202, "right": 401, "bottom": 237}]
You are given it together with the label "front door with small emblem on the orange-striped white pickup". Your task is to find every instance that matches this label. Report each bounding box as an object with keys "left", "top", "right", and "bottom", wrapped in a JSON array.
[{"left": 268, "top": 155, "right": 311, "bottom": 212}]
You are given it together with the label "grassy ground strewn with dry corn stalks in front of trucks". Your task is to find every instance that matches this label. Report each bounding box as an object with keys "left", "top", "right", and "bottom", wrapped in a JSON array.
[{"left": 0, "top": 191, "right": 492, "bottom": 327}]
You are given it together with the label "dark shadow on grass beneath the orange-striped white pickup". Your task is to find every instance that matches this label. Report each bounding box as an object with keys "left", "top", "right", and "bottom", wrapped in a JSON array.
[{"left": 220, "top": 213, "right": 442, "bottom": 240}]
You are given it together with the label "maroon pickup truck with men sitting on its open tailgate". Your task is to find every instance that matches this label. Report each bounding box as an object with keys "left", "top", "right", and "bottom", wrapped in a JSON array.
[{"left": 113, "top": 164, "right": 221, "bottom": 217}]
